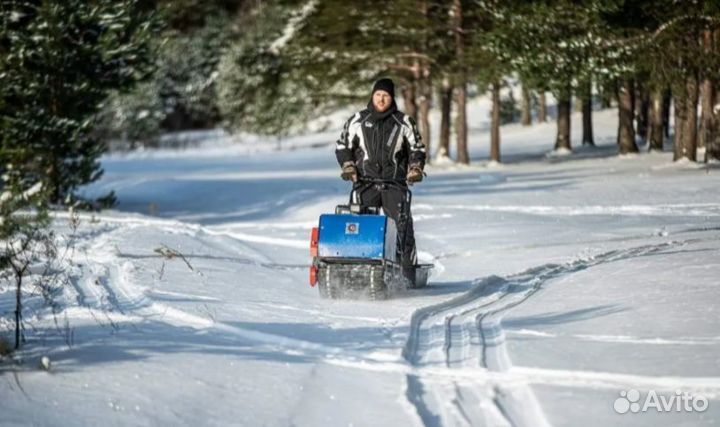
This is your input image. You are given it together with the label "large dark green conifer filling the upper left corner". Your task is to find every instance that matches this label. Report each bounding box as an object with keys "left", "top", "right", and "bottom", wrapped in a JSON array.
[{"left": 0, "top": 0, "right": 154, "bottom": 203}]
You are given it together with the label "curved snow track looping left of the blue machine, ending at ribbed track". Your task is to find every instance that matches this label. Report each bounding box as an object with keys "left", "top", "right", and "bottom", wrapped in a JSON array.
[{"left": 58, "top": 215, "right": 382, "bottom": 363}]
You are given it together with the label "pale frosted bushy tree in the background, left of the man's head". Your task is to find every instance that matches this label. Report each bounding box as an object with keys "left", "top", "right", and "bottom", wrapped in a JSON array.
[{"left": 217, "top": 1, "right": 315, "bottom": 135}]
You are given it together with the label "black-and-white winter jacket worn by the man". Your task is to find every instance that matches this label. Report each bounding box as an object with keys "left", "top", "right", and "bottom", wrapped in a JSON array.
[{"left": 335, "top": 101, "right": 425, "bottom": 180}]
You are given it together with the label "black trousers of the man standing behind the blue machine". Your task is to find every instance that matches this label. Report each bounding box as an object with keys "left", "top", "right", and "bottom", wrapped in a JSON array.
[{"left": 354, "top": 184, "right": 417, "bottom": 272}]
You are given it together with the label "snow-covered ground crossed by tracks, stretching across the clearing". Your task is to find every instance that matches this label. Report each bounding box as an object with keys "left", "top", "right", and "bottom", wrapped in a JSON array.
[{"left": 0, "top": 102, "right": 720, "bottom": 426}]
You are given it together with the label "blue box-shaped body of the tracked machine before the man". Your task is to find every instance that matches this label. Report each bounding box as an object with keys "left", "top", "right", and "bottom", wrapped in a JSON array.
[{"left": 318, "top": 214, "right": 397, "bottom": 261}]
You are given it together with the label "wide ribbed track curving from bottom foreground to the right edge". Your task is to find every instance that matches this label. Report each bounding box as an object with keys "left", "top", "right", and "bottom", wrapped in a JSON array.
[{"left": 403, "top": 238, "right": 716, "bottom": 426}]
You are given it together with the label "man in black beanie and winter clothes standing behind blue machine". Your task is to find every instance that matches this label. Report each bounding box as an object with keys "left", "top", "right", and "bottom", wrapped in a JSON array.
[{"left": 335, "top": 79, "right": 425, "bottom": 284}]
